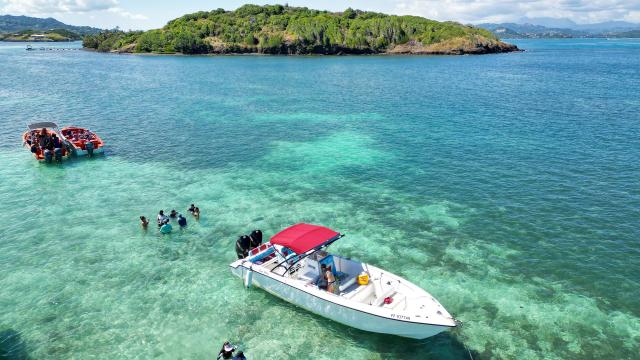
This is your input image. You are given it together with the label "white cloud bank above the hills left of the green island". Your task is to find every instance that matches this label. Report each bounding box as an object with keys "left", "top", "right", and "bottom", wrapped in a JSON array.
[{"left": 0, "top": 0, "right": 148, "bottom": 20}]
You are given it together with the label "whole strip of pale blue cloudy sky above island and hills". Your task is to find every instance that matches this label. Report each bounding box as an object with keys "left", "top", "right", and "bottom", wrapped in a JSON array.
[{"left": 0, "top": 0, "right": 640, "bottom": 29}]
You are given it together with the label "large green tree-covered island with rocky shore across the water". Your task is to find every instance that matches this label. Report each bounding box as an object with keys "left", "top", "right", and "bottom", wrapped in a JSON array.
[{"left": 83, "top": 5, "right": 519, "bottom": 55}]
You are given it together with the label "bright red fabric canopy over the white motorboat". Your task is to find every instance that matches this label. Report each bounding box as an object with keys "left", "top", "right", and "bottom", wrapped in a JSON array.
[{"left": 271, "top": 224, "right": 340, "bottom": 254}]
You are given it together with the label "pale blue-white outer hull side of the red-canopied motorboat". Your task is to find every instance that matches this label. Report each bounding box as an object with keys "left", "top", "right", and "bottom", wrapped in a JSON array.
[{"left": 231, "top": 266, "right": 449, "bottom": 339}]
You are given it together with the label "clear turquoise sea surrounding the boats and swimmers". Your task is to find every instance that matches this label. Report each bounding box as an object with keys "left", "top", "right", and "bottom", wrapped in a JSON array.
[{"left": 0, "top": 39, "right": 640, "bottom": 360}]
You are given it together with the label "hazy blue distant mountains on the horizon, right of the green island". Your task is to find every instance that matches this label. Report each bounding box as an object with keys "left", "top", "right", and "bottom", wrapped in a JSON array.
[{"left": 477, "top": 19, "right": 640, "bottom": 39}]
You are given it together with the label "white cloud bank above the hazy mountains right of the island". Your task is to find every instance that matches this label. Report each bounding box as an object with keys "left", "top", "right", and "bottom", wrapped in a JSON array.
[{"left": 395, "top": 0, "right": 640, "bottom": 23}]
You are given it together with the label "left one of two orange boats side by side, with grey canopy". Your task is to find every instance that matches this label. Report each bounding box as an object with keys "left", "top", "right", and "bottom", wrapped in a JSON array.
[{"left": 22, "top": 122, "right": 69, "bottom": 162}]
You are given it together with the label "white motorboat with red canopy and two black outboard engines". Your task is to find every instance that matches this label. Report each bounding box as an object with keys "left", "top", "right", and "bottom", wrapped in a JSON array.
[{"left": 230, "top": 224, "right": 456, "bottom": 339}]
